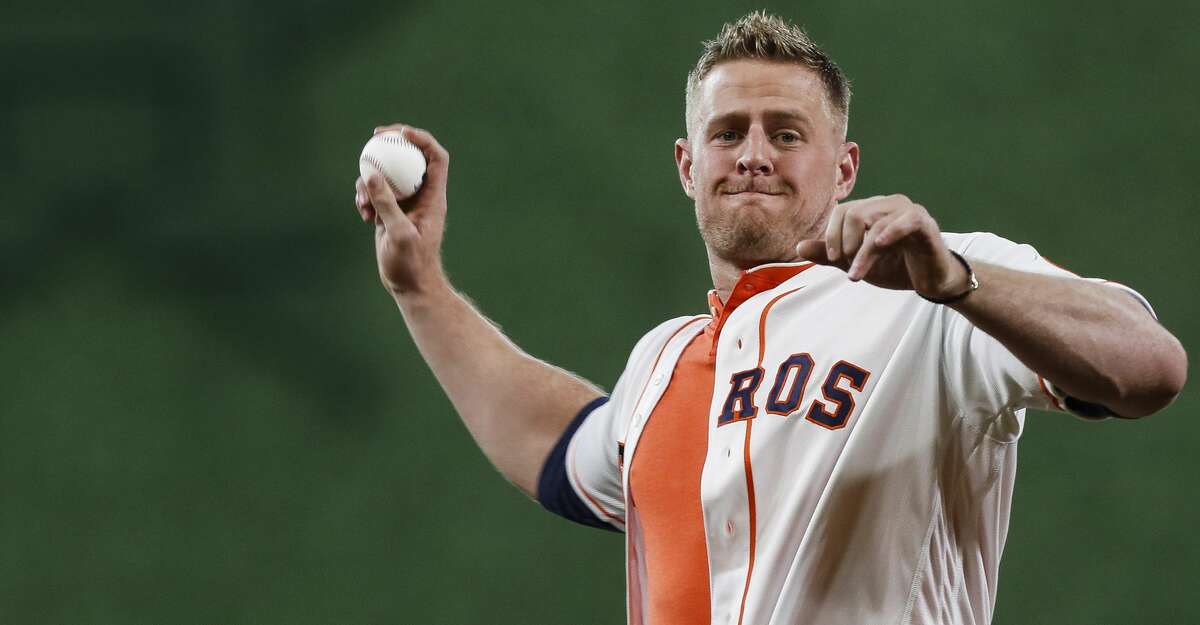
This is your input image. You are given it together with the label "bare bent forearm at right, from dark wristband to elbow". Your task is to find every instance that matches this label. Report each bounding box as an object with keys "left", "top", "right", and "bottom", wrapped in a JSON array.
[{"left": 953, "top": 263, "right": 1187, "bottom": 417}]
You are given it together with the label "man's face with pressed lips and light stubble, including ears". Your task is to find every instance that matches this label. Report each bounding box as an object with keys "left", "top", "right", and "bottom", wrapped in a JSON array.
[{"left": 676, "top": 60, "right": 858, "bottom": 269}]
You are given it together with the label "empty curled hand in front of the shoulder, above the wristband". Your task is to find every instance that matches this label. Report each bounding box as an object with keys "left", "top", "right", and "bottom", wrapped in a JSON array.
[{"left": 796, "top": 196, "right": 968, "bottom": 300}]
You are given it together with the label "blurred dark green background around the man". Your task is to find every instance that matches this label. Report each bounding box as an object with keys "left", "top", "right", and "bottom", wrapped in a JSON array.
[{"left": 0, "top": 0, "right": 1200, "bottom": 625}]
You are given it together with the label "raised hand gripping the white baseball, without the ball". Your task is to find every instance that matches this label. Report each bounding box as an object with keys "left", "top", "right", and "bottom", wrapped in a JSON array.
[{"left": 354, "top": 124, "right": 450, "bottom": 298}]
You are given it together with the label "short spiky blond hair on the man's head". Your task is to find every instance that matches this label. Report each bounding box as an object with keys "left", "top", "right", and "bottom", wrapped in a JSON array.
[{"left": 684, "top": 11, "right": 850, "bottom": 134}]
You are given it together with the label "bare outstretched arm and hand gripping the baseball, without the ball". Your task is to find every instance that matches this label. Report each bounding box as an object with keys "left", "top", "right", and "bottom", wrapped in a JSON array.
[{"left": 355, "top": 125, "right": 604, "bottom": 497}]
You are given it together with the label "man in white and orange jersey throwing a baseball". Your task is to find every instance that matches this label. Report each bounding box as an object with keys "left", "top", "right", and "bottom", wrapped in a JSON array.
[{"left": 356, "top": 13, "right": 1187, "bottom": 625}]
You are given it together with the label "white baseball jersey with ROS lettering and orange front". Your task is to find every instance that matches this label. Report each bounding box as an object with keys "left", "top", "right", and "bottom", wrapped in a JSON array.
[{"left": 539, "top": 233, "right": 1148, "bottom": 625}]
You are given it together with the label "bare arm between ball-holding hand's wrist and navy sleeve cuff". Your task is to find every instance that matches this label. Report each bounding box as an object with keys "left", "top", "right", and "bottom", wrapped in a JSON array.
[{"left": 396, "top": 284, "right": 604, "bottom": 495}]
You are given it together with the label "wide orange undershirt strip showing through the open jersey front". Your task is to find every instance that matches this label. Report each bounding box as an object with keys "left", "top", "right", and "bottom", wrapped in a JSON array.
[{"left": 629, "top": 326, "right": 715, "bottom": 625}]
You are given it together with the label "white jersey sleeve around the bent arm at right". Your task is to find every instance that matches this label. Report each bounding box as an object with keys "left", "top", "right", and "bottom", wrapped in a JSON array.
[{"left": 941, "top": 233, "right": 1153, "bottom": 434}]
